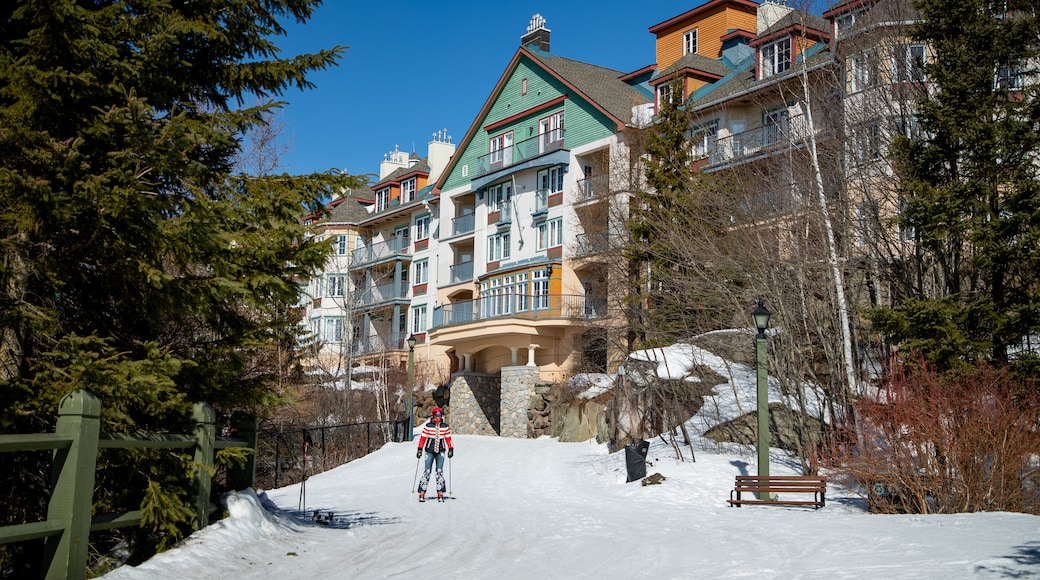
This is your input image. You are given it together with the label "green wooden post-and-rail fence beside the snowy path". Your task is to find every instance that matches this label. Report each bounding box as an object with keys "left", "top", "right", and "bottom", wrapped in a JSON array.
[{"left": 0, "top": 390, "right": 257, "bottom": 579}]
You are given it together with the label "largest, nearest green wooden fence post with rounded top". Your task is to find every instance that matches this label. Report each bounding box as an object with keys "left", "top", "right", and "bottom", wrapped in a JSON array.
[{"left": 44, "top": 389, "right": 101, "bottom": 580}]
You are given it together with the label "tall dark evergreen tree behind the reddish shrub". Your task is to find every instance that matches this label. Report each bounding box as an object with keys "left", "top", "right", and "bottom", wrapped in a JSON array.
[{"left": 872, "top": 0, "right": 1040, "bottom": 368}]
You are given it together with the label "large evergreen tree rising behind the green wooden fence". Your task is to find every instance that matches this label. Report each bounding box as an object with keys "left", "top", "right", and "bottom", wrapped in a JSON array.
[{"left": 0, "top": 0, "right": 359, "bottom": 573}]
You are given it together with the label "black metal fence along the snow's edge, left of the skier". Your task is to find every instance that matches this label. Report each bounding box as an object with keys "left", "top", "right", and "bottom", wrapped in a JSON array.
[{"left": 256, "top": 420, "right": 408, "bottom": 490}]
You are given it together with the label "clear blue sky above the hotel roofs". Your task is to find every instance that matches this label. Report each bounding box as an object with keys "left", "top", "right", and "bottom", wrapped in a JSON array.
[{"left": 277, "top": 0, "right": 703, "bottom": 181}]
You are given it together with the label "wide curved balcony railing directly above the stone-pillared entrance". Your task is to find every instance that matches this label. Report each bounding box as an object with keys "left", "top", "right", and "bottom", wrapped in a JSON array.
[{"left": 432, "top": 294, "right": 606, "bottom": 328}]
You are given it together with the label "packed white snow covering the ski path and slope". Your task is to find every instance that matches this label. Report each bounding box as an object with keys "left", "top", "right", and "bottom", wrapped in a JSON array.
[{"left": 106, "top": 345, "right": 1040, "bottom": 580}]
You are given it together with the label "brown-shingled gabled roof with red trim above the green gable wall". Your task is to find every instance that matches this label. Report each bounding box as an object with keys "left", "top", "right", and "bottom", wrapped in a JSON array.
[{"left": 434, "top": 47, "right": 651, "bottom": 193}]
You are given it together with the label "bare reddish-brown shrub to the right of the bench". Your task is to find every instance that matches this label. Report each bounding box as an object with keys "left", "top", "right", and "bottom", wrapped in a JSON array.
[{"left": 829, "top": 363, "right": 1040, "bottom": 513}]
